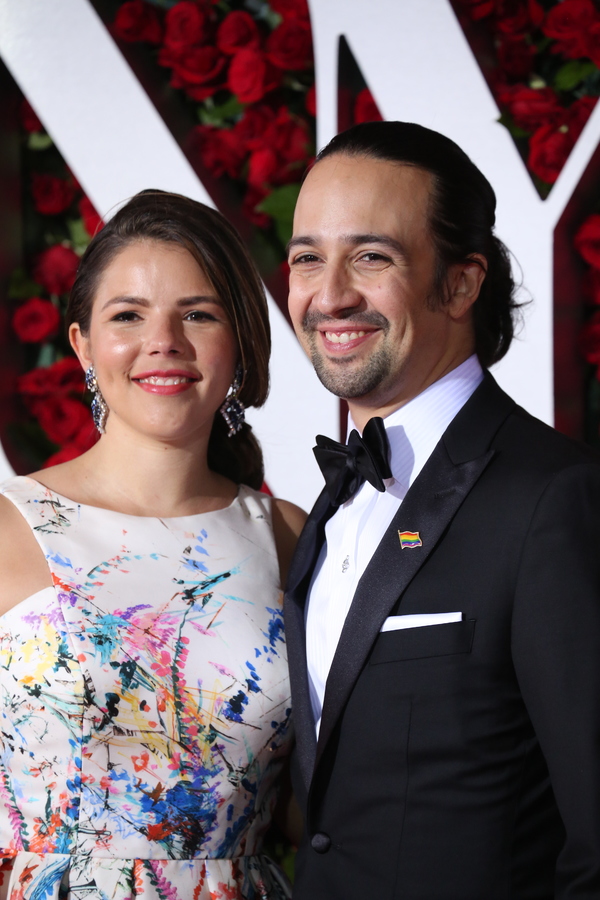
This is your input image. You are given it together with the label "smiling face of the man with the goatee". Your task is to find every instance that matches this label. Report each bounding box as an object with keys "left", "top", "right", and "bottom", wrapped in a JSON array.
[{"left": 289, "top": 154, "right": 472, "bottom": 424}]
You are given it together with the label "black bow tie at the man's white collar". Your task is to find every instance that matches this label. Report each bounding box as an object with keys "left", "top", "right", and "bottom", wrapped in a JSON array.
[{"left": 313, "top": 416, "right": 392, "bottom": 506}]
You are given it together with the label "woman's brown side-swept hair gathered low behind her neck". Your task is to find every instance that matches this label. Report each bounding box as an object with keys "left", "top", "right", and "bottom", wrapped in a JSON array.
[{"left": 66, "top": 190, "right": 271, "bottom": 488}]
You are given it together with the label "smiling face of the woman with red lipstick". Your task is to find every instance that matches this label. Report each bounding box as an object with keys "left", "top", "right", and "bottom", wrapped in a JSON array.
[{"left": 70, "top": 240, "right": 238, "bottom": 443}]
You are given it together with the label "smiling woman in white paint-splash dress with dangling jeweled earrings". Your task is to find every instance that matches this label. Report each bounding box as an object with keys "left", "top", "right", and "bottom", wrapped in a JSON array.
[{"left": 0, "top": 191, "right": 303, "bottom": 900}]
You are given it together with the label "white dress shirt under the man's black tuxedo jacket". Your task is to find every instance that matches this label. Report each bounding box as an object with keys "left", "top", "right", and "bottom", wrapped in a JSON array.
[{"left": 306, "top": 356, "right": 483, "bottom": 735}]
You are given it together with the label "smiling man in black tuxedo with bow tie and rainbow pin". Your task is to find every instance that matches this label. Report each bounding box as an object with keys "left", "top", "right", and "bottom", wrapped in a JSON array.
[{"left": 285, "top": 122, "right": 600, "bottom": 900}]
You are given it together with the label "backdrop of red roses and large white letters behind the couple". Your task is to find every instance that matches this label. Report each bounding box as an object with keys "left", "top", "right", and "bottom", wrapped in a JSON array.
[{"left": 0, "top": 0, "right": 600, "bottom": 506}]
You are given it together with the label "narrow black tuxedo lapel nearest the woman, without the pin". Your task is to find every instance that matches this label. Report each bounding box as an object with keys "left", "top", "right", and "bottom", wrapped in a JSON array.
[{"left": 284, "top": 490, "right": 335, "bottom": 791}]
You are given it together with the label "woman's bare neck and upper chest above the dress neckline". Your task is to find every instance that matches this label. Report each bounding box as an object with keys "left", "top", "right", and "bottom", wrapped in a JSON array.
[{"left": 33, "top": 429, "right": 237, "bottom": 518}]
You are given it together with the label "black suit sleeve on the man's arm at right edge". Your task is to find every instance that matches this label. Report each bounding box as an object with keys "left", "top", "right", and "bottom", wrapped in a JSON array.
[{"left": 512, "top": 464, "right": 600, "bottom": 900}]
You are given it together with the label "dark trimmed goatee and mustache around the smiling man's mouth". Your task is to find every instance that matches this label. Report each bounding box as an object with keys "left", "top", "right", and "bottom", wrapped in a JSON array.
[{"left": 302, "top": 312, "right": 393, "bottom": 400}]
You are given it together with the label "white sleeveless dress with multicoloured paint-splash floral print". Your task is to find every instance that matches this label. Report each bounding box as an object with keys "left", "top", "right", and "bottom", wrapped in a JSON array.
[{"left": 0, "top": 477, "right": 291, "bottom": 900}]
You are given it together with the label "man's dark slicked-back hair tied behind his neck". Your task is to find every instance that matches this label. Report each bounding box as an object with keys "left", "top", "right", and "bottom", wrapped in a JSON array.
[{"left": 316, "top": 122, "right": 520, "bottom": 368}]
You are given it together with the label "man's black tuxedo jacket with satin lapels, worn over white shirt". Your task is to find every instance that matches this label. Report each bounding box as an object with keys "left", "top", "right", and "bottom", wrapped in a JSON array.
[{"left": 285, "top": 374, "right": 600, "bottom": 900}]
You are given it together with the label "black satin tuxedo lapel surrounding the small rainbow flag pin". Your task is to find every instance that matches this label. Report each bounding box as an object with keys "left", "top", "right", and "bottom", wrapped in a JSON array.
[{"left": 315, "top": 375, "right": 514, "bottom": 765}]
